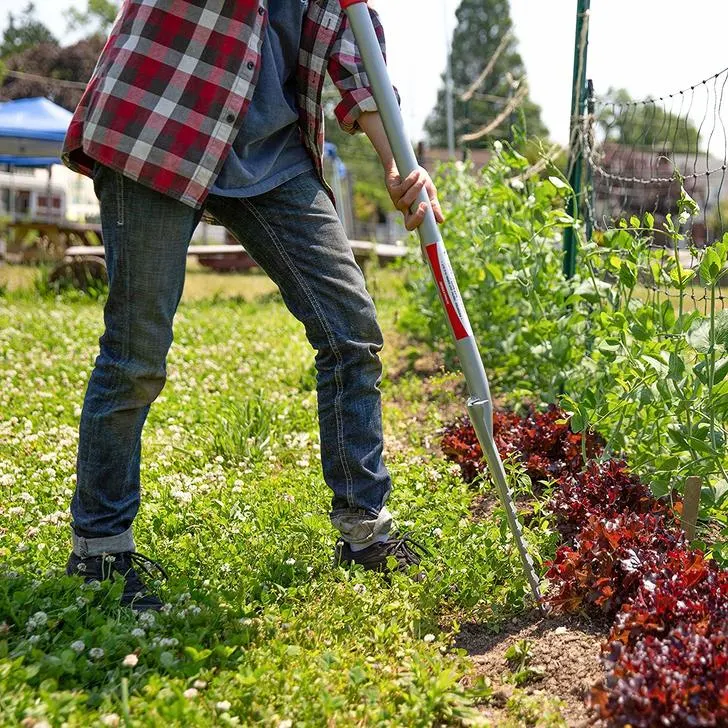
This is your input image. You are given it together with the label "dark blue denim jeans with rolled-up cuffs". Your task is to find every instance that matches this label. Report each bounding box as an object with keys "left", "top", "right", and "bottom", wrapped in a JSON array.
[{"left": 71, "top": 165, "right": 391, "bottom": 557}]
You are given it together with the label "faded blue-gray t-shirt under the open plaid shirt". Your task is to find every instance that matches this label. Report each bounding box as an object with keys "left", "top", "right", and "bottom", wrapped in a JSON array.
[{"left": 211, "top": 0, "right": 313, "bottom": 197}]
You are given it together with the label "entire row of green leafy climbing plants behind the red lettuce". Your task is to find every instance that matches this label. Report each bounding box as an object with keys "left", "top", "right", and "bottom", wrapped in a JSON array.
[{"left": 400, "top": 146, "right": 728, "bottom": 559}]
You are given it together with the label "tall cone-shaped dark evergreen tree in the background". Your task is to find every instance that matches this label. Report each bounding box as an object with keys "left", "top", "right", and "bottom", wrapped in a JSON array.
[{"left": 425, "top": 0, "right": 547, "bottom": 147}]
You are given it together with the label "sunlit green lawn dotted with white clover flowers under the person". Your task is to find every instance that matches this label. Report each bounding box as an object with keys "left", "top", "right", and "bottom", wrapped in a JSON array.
[{"left": 0, "top": 267, "right": 564, "bottom": 728}]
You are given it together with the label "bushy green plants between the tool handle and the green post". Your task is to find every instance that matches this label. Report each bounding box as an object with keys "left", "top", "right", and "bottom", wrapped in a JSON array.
[{"left": 400, "top": 145, "right": 580, "bottom": 404}]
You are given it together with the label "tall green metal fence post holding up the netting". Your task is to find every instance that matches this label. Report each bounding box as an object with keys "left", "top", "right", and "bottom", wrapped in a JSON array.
[{"left": 563, "top": 0, "right": 591, "bottom": 278}]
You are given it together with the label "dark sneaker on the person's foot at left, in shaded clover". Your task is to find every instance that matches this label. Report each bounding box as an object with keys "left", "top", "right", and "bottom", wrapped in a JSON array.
[{"left": 66, "top": 551, "right": 167, "bottom": 612}]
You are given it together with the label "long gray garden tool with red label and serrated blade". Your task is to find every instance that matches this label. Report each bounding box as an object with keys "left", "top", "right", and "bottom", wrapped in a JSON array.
[{"left": 340, "top": 0, "right": 541, "bottom": 604}]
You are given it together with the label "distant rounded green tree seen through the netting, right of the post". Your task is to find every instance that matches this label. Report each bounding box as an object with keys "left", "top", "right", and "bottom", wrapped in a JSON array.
[{"left": 597, "top": 88, "right": 700, "bottom": 154}]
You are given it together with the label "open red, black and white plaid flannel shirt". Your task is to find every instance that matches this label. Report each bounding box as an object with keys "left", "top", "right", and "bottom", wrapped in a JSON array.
[{"left": 63, "top": 0, "right": 392, "bottom": 208}]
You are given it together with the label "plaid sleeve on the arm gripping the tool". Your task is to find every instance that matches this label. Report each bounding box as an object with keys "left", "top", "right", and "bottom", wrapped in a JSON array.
[{"left": 328, "top": 8, "right": 399, "bottom": 134}]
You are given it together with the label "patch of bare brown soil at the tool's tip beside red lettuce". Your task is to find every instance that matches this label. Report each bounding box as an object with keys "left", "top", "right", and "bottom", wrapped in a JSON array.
[{"left": 457, "top": 613, "right": 608, "bottom": 728}]
